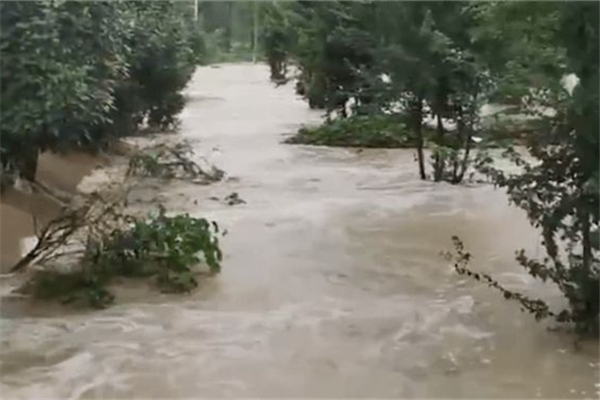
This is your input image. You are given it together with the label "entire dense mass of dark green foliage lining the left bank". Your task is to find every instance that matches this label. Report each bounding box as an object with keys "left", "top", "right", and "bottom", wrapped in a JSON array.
[{"left": 0, "top": 1, "right": 203, "bottom": 180}]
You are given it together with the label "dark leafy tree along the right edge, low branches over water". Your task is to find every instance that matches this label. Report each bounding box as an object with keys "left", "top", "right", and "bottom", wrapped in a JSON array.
[{"left": 454, "top": 2, "right": 600, "bottom": 333}]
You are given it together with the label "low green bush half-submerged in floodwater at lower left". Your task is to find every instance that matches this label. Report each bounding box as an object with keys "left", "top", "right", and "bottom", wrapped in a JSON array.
[{"left": 31, "top": 207, "right": 222, "bottom": 308}]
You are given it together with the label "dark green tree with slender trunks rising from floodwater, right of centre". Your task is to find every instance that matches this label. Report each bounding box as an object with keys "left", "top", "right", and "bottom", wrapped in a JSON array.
[{"left": 366, "top": 2, "right": 489, "bottom": 183}]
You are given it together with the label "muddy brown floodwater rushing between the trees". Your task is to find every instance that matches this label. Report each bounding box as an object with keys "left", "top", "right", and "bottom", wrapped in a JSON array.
[{"left": 0, "top": 64, "right": 600, "bottom": 399}]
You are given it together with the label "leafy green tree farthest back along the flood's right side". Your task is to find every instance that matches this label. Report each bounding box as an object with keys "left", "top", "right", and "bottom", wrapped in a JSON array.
[{"left": 265, "top": 2, "right": 373, "bottom": 118}]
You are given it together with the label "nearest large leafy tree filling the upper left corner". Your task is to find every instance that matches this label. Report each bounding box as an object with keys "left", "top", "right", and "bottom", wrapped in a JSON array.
[{"left": 0, "top": 2, "right": 126, "bottom": 180}]
